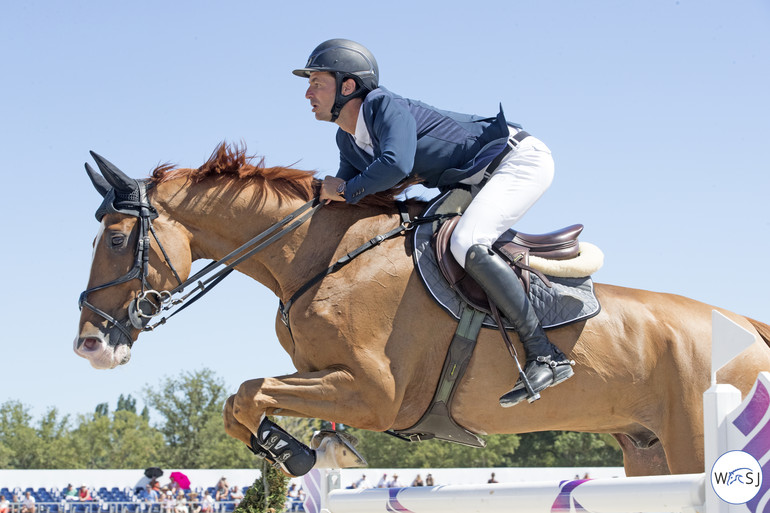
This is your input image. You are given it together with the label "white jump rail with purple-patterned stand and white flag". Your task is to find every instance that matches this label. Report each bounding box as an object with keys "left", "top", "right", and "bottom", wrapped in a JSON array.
[{"left": 303, "top": 311, "right": 770, "bottom": 513}]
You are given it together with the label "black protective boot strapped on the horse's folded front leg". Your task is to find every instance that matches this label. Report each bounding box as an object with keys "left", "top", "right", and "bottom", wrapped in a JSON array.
[{"left": 249, "top": 417, "right": 316, "bottom": 477}]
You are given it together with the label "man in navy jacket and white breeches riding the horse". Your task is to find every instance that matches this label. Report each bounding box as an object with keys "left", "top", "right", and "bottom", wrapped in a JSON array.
[{"left": 294, "top": 39, "right": 573, "bottom": 407}]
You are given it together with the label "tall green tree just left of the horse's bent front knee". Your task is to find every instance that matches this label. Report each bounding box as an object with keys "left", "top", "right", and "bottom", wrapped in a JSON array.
[{"left": 144, "top": 369, "right": 232, "bottom": 468}]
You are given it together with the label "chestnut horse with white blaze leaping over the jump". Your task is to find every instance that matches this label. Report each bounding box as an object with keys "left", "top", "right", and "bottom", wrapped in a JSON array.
[{"left": 74, "top": 144, "right": 770, "bottom": 476}]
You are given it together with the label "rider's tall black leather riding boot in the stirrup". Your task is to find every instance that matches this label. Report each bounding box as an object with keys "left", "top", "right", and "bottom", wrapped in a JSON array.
[{"left": 465, "top": 244, "right": 574, "bottom": 407}]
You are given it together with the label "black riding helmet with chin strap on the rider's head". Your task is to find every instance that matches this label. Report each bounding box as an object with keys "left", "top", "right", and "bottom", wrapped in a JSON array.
[{"left": 292, "top": 39, "right": 380, "bottom": 121}]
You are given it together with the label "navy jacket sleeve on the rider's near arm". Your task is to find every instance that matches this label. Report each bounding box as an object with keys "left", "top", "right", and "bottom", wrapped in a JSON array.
[{"left": 337, "top": 96, "right": 417, "bottom": 203}]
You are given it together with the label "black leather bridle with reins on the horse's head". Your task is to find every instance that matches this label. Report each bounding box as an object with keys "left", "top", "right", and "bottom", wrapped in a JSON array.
[{"left": 78, "top": 180, "right": 323, "bottom": 346}]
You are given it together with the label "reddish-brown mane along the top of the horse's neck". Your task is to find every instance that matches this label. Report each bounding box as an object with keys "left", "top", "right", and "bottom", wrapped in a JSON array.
[{"left": 150, "top": 142, "right": 416, "bottom": 206}]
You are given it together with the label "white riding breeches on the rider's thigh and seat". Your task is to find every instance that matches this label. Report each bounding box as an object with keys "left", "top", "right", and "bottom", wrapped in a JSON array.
[{"left": 450, "top": 129, "right": 554, "bottom": 267}]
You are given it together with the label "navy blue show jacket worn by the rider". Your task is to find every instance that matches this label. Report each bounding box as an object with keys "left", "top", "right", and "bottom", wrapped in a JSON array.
[{"left": 337, "top": 87, "right": 521, "bottom": 203}]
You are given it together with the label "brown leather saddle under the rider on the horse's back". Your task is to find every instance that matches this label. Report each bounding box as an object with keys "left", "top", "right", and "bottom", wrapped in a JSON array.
[{"left": 431, "top": 216, "right": 583, "bottom": 312}]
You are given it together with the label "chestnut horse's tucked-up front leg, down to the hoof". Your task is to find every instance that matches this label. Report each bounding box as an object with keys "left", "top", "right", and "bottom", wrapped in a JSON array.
[{"left": 224, "top": 368, "right": 390, "bottom": 474}]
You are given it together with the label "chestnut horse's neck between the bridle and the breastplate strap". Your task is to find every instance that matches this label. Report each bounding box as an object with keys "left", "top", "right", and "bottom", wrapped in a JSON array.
[{"left": 158, "top": 180, "right": 394, "bottom": 300}]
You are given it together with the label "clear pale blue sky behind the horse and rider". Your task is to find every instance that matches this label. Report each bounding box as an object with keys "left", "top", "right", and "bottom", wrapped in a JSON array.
[{"left": 0, "top": 0, "right": 770, "bottom": 422}]
